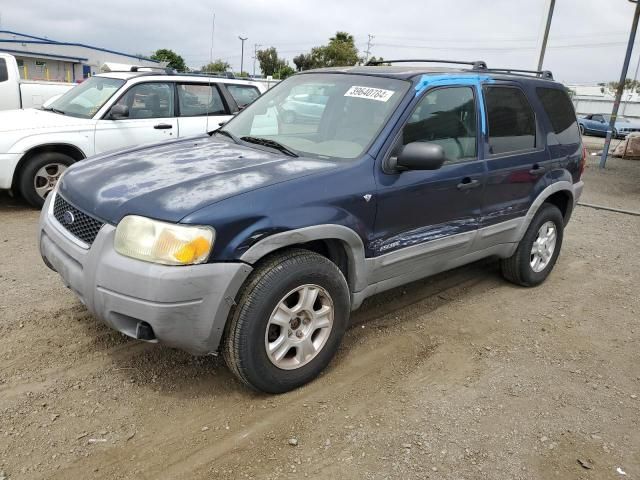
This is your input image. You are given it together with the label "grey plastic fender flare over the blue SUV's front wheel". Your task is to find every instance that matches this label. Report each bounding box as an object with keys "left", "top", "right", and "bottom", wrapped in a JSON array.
[{"left": 240, "top": 224, "right": 367, "bottom": 292}]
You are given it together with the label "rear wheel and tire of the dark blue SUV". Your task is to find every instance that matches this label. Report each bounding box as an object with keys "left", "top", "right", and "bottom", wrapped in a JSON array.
[{"left": 500, "top": 203, "right": 564, "bottom": 287}]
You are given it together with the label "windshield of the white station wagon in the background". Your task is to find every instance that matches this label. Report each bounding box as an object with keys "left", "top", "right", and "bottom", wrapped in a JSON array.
[{"left": 46, "top": 77, "right": 124, "bottom": 118}]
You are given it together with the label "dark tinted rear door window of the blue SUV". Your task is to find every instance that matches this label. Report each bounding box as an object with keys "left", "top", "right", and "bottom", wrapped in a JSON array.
[{"left": 485, "top": 87, "right": 536, "bottom": 154}]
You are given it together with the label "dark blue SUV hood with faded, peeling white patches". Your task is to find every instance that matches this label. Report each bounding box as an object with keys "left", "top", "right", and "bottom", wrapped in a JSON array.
[{"left": 60, "top": 135, "right": 338, "bottom": 224}]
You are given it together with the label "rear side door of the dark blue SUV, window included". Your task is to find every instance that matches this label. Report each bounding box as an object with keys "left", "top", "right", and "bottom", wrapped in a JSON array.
[{"left": 478, "top": 82, "right": 551, "bottom": 244}]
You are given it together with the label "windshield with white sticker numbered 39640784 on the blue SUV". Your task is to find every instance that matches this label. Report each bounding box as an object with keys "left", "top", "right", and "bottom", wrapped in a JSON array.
[{"left": 222, "top": 73, "right": 410, "bottom": 159}]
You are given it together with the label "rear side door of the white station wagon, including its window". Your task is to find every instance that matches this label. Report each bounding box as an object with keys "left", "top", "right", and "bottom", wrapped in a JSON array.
[{"left": 177, "top": 82, "right": 231, "bottom": 137}]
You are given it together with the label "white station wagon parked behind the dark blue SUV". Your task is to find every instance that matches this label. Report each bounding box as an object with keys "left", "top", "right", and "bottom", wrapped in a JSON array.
[{"left": 0, "top": 67, "right": 266, "bottom": 207}]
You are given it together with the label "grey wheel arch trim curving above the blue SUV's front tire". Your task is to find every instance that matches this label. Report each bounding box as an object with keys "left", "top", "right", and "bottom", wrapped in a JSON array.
[{"left": 240, "top": 225, "right": 366, "bottom": 292}]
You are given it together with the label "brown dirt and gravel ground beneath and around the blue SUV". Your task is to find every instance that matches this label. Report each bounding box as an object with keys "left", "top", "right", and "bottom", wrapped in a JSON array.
[{"left": 0, "top": 144, "right": 640, "bottom": 480}]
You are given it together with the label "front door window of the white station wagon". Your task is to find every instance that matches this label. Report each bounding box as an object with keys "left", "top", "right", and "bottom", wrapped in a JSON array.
[{"left": 116, "top": 82, "right": 173, "bottom": 119}]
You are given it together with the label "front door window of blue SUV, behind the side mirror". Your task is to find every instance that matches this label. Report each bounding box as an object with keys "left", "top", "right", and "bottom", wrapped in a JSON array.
[{"left": 403, "top": 87, "right": 477, "bottom": 163}]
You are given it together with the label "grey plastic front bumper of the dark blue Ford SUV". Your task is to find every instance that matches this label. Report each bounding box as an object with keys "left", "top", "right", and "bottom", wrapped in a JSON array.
[{"left": 39, "top": 195, "right": 252, "bottom": 355}]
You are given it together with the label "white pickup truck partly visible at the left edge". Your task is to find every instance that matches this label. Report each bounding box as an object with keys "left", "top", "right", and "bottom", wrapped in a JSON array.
[{"left": 0, "top": 53, "right": 75, "bottom": 110}]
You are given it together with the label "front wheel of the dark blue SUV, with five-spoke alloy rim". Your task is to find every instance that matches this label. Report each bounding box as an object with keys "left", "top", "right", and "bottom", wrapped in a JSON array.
[{"left": 222, "top": 249, "right": 351, "bottom": 393}]
